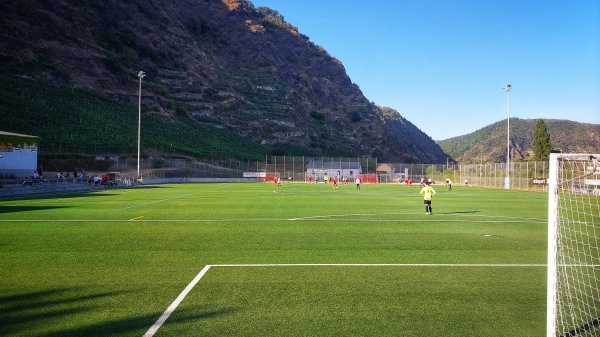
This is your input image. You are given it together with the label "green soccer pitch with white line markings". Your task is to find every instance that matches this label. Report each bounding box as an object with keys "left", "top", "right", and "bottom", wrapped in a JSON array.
[{"left": 0, "top": 183, "right": 547, "bottom": 337}]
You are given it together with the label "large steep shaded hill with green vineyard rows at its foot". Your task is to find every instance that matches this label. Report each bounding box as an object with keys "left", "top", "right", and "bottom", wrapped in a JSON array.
[{"left": 0, "top": 0, "right": 447, "bottom": 163}]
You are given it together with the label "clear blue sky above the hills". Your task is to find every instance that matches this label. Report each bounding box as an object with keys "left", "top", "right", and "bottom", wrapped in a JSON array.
[{"left": 251, "top": 0, "right": 600, "bottom": 140}]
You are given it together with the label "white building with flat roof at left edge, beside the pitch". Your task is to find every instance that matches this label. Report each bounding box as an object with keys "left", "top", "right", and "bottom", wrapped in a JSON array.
[{"left": 0, "top": 131, "right": 40, "bottom": 179}]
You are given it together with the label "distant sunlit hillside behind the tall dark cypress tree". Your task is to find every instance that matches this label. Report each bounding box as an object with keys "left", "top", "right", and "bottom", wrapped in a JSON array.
[{"left": 437, "top": 118, "right": 600, "bottom": 163}]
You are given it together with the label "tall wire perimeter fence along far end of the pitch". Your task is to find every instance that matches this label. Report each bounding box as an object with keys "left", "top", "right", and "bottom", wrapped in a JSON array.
[{"left": 112, "top": 156, "right": 548, "bottom": 191}]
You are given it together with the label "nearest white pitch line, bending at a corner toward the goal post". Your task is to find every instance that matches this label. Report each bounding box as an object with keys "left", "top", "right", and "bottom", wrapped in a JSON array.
[{"left": 143, "top": 263, "right": 546, "bottom": 337}]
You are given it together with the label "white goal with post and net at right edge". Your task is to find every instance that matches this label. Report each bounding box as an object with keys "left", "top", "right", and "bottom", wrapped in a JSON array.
[{"left": 546, "top": 154, "right": 600, "bottom": 337}]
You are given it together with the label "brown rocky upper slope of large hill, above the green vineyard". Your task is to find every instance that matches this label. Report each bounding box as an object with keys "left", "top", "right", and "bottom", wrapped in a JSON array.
[{"left": 0, "top": 0, "right": 446, "bottom": 162}]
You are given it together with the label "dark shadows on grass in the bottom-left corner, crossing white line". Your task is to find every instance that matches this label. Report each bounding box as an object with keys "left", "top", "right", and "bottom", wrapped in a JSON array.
[{"left": 0, "top": 289, "right": 236, "bottom": 337}]
